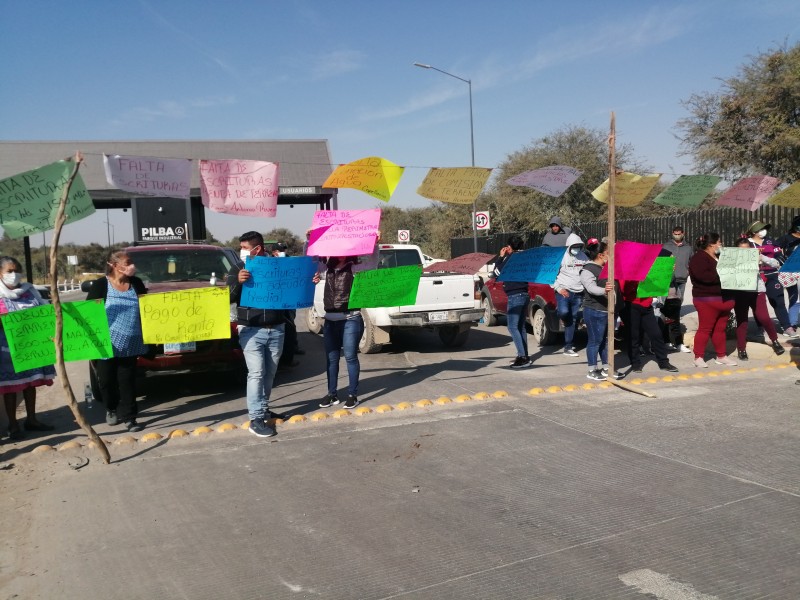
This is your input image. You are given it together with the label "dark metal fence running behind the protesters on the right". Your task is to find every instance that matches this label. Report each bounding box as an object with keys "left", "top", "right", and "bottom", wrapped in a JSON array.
[{"left": 450, "top": 205, "right": 800, "bottom": 258}]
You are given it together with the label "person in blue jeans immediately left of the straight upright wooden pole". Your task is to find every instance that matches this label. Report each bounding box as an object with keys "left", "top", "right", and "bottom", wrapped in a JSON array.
[{"left": 580, "top": 241, "right": 614, "bottom": 381}]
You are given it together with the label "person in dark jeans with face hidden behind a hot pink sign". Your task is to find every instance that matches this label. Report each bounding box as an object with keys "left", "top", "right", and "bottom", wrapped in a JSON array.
[{"left": 314, "top": 233, "right": 380, "bottom": 408}]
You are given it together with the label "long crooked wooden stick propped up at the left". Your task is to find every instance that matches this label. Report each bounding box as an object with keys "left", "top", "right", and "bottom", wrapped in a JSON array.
[{"left": 50, "top": 152, "right": 111, "bottom": 464}]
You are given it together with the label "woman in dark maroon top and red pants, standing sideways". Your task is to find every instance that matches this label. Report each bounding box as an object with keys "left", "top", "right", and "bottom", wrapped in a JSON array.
[{"left": 689, "top": 232, "right": 736, "bottom": 369}]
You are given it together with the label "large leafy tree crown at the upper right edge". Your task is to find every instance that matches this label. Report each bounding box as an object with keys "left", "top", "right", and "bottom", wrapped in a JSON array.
[{"left": 677, "top": 44, "right": 800, "bottom": 182}]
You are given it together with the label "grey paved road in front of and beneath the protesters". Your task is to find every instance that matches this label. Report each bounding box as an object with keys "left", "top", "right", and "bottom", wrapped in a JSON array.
[{"left": 0, "top": 312, "right": 800, "bottom": 599}]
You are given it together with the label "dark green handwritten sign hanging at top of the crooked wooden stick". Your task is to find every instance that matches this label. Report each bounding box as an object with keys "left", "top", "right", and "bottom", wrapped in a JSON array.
[{"left": 0, "top": 161, "right": 94, "bottom": 239}]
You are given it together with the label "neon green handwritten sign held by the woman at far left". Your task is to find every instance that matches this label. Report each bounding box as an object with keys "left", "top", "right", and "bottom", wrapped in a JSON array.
[{"left": 3, "top": 300, "right": 114, "bottom": 373}]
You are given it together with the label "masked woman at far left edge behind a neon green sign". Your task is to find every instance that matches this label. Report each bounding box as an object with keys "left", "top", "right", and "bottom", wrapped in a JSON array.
[{"left": 0, "top": 256, "right": 56, "bottom": 440}]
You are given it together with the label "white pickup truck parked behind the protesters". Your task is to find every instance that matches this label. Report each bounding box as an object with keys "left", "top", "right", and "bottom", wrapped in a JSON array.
[{"left": 306, "top": 244, "right": 483, "bottom": 354}]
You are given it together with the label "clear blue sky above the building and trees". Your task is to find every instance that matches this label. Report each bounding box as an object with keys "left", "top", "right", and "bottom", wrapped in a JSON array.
[{"left": 0, "top": 0, "right": 800, "bottom": 245}]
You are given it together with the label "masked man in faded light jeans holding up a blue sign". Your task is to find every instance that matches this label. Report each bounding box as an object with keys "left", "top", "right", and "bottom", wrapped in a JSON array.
[{"left": 227, "top": 231, "right": 286, "bottom": 437}]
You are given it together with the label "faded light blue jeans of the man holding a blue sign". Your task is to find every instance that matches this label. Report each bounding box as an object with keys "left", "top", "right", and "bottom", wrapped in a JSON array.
[{"left": 239, "top": 324, "right": 284, "bottom": 421}]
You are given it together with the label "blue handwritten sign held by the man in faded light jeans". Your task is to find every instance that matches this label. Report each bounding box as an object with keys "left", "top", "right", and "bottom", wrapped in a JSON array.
[{"left": 239, "top": 256, "right": 317, "bottom": 310}]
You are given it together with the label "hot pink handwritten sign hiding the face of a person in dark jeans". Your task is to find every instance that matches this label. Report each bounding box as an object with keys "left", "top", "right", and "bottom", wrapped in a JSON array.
[{"left": 306, "top": 208, "right": 381, "bottom": 256}]
